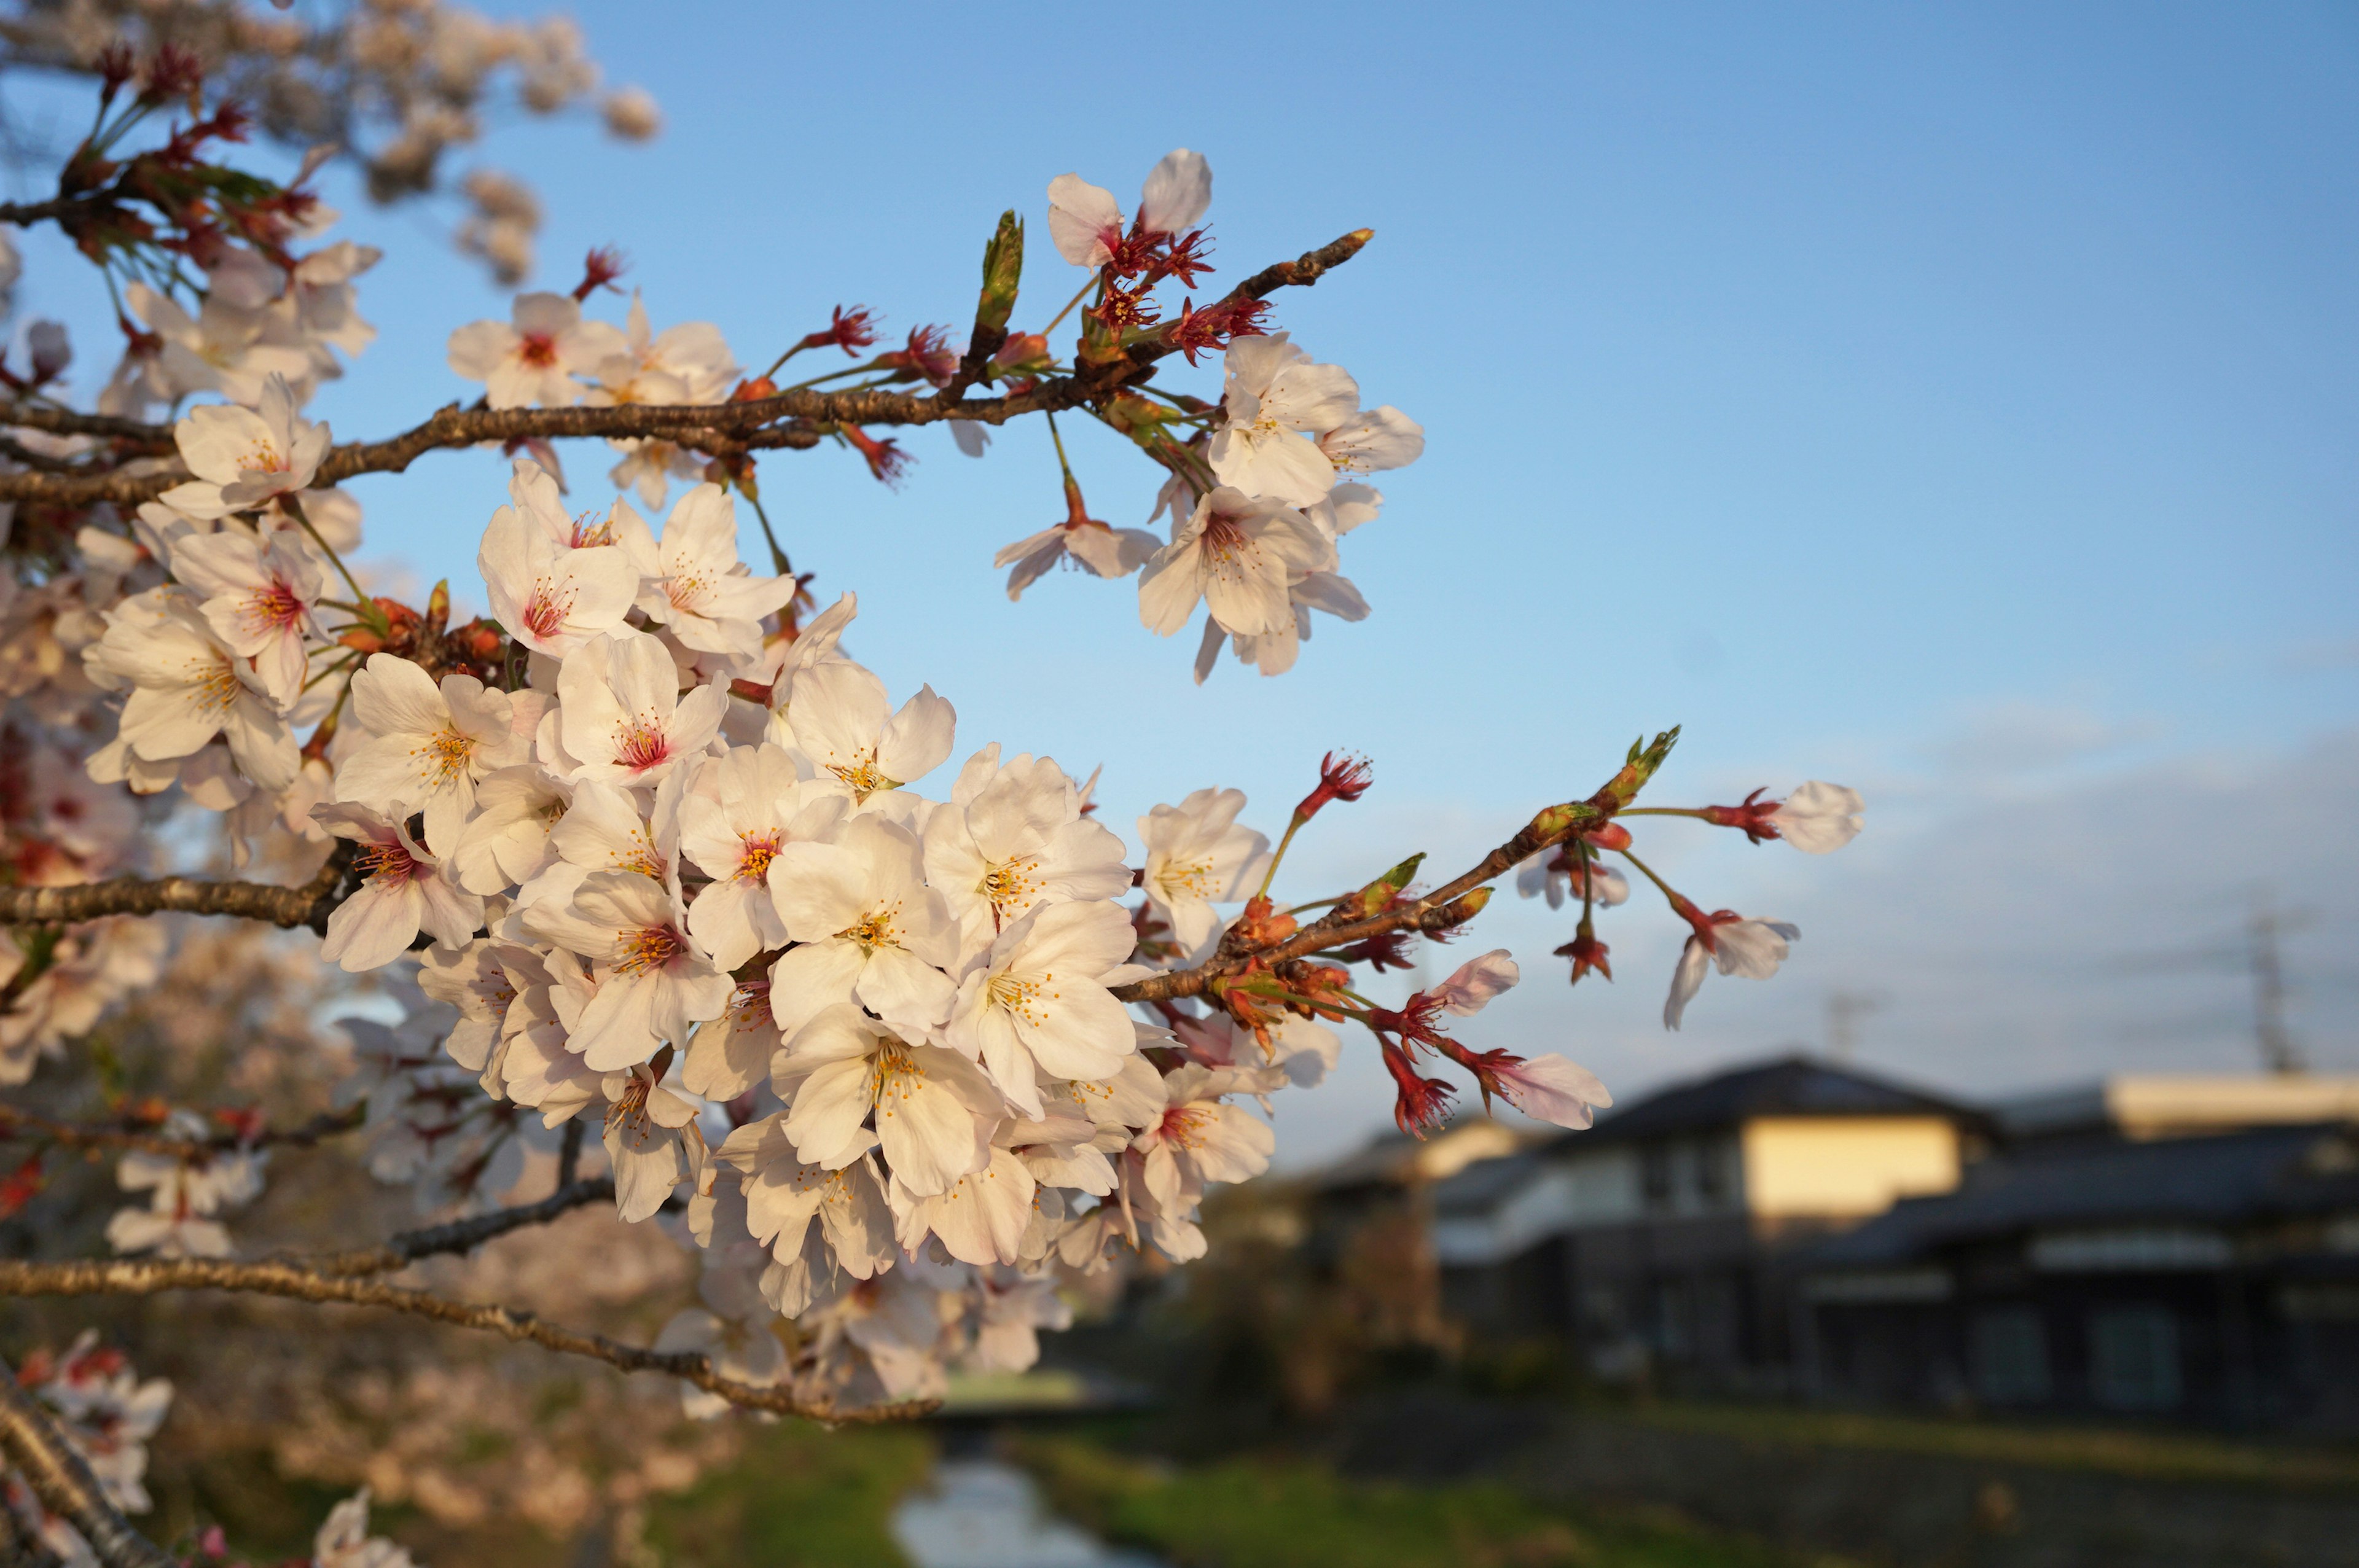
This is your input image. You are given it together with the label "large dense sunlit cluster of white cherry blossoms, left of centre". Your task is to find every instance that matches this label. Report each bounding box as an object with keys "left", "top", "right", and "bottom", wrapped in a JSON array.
[{"left": 69, "top": 380, "right": 1335, "bottom": 1398}]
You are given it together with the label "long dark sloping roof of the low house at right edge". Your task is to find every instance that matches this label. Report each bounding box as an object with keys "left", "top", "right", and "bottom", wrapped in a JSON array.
[{"left": 1809, "top": 1125, "right": 2359, "bottom": 1268}]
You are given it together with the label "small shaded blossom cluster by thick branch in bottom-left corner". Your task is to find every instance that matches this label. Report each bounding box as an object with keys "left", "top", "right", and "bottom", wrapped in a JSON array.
[{"left": 0, "top": 1327, "right": 172, "bottom": 1568}]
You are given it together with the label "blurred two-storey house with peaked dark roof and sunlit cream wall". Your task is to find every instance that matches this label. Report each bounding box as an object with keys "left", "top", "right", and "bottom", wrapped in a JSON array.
[{"left": 1427, "top": 1056, "right": 1989, "bottom": 1386}]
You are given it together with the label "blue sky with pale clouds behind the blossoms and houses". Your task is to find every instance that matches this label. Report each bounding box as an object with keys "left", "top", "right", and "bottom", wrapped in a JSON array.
[{"left": 23, "top": 5, "right": 2359, "bottom": 1160}]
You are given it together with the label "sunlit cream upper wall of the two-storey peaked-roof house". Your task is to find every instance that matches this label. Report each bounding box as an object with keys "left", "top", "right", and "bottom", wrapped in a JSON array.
[{"left": 1741, "top": 1115, "right": 1960, "bottom": 1219}]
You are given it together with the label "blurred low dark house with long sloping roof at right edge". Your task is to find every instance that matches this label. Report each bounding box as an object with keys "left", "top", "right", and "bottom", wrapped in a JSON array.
[{"left": 1798, "top": 1113, "right": 2359, "bottom": 1433}]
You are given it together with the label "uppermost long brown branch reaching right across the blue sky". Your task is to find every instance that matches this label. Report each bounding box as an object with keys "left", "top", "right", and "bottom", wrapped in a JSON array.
[{"left": 0, "top": 228, "right": 1371, "bottom": 505}]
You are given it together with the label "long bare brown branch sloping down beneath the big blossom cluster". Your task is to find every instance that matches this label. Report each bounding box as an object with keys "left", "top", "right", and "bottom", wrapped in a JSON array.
[{"left": 0, "top": 1257, "right": 932, "bottom": 1424}]
